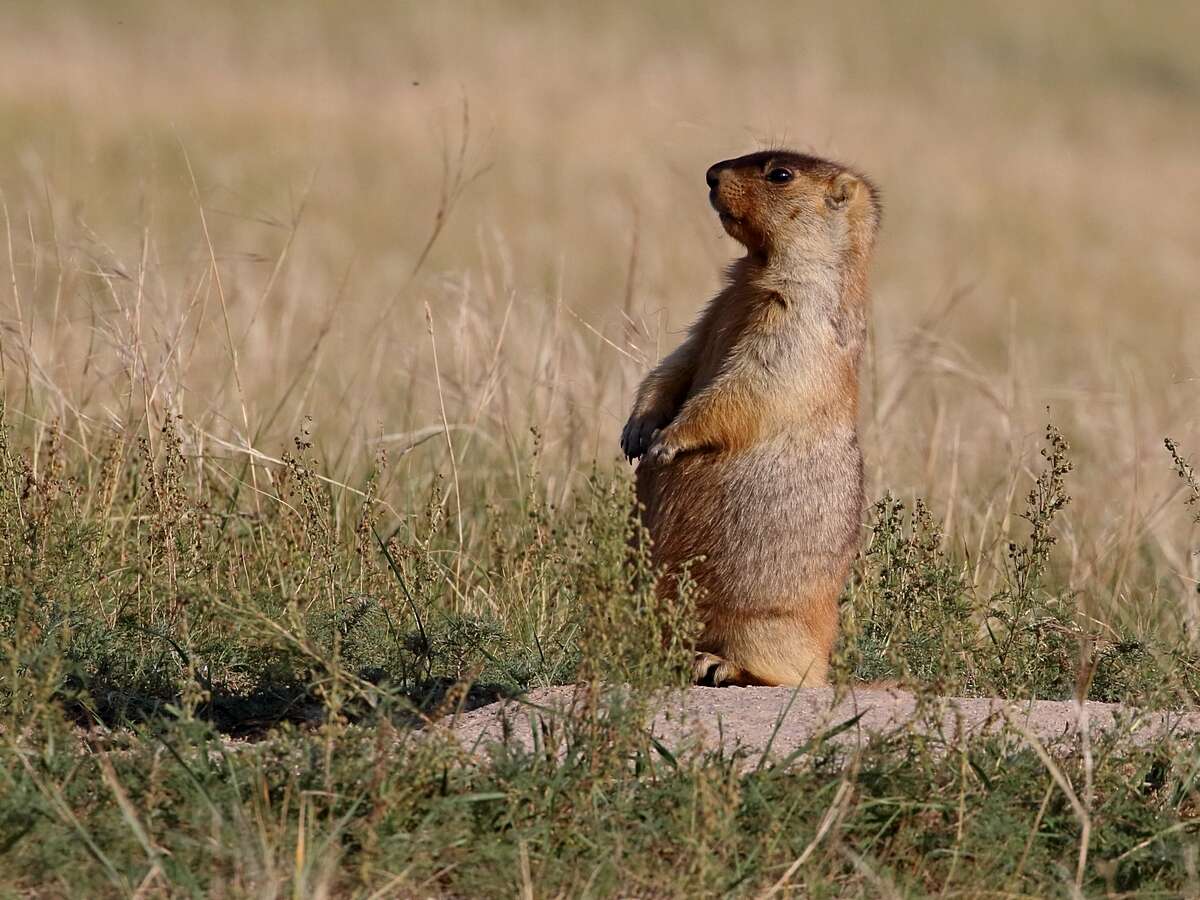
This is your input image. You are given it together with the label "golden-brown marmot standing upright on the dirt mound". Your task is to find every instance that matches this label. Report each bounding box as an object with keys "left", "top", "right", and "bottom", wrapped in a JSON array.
[{"left": 620, "top": 150, "right": 881, "bottom": 685}]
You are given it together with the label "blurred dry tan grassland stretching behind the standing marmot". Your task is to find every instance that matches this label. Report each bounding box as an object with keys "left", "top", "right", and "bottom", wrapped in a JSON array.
[{"left": 0, "top": 0, "right": 1200, "bottom": 643}]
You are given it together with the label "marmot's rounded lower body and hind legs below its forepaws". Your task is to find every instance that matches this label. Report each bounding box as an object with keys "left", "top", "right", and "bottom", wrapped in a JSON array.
[{"left": 637, "top": 427, "right": 862, "bottom": 684}]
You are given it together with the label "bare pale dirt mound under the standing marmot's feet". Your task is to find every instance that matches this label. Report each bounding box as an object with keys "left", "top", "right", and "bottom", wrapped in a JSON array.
[{"left": 443, "top": 685, "right": 1200, "bottom": 760}]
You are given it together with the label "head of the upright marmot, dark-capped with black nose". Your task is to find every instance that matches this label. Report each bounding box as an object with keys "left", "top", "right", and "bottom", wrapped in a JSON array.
[{"left": 706, "top": 150, "right": 881, "bottom": 259}]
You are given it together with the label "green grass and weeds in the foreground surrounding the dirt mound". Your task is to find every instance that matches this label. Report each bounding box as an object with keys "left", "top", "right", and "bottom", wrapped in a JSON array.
[{"left": 0, "top": 412, "right": 1200, "bottom": 896}]
